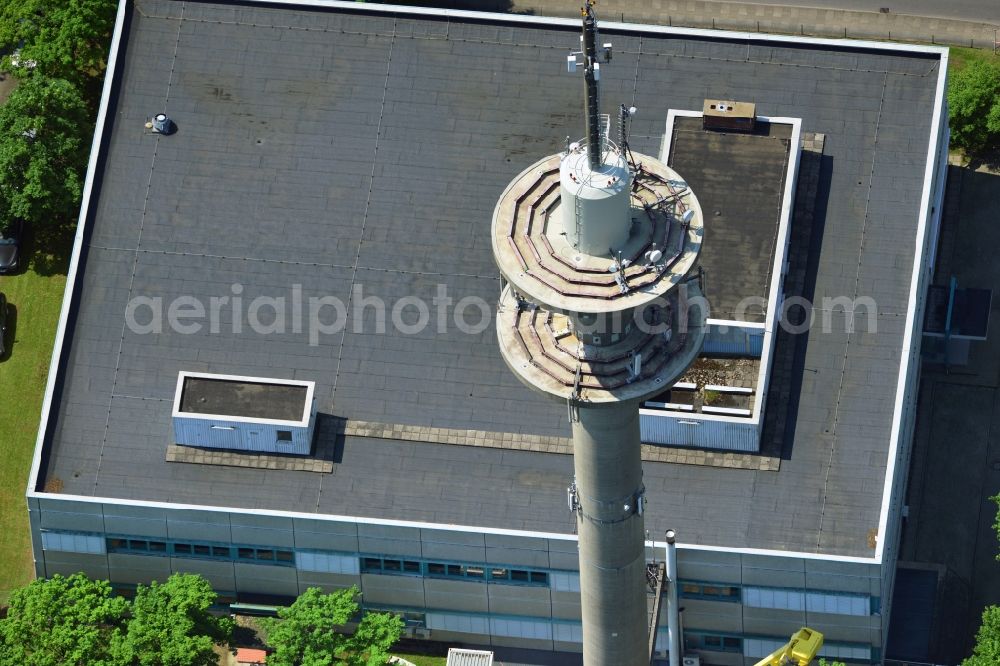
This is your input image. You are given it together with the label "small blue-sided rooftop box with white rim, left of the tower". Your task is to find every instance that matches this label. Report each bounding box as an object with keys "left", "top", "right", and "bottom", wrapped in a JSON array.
[{"left": 173, "top": 372, "right": 316, "bottom": 455}]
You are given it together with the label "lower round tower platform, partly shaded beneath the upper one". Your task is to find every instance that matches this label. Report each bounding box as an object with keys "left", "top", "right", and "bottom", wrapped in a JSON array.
[{"left": 497, "top": 281, "right": 707, "bottom": 407}]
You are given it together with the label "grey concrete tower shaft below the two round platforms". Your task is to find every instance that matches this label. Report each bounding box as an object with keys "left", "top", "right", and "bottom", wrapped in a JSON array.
[{"left": 573, "top": 401, "right": 649, "bottom": 666}]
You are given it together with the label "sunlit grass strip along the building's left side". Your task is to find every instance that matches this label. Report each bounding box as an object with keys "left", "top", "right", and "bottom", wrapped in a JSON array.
[{"left": 0, "top": 247, "right": 66, "bottom": 604}]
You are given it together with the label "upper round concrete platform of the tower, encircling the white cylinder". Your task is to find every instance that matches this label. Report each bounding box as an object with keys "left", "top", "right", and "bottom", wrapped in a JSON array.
[{"left": 492, "top": 153, "right": 704, "bottom": 313}]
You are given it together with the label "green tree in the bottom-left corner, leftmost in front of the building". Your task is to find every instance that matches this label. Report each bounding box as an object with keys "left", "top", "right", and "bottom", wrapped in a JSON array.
[{"left": 0, "top": 574, "right": 128, "bottom": 666}]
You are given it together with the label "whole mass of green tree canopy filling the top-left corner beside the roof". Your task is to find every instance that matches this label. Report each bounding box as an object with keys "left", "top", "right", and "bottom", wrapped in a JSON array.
[{"left": 0, "top": 0, "right": 117, "bottom": 236}]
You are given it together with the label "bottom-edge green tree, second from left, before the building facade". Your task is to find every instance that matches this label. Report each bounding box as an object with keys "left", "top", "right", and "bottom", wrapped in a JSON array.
[{"left": 113, "top": 574, "right": 233, "bottom": 666}]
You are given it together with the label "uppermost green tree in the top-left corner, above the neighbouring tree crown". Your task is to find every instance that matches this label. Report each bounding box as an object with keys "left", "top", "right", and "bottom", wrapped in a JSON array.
[{"left": 0, "top": 0, "right": 118, "bottom": 101}]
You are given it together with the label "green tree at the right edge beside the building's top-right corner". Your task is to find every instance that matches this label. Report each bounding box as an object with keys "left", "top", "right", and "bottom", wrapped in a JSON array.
[{"left": 948, "top": 60, "right": 1000, "bottom": 152}]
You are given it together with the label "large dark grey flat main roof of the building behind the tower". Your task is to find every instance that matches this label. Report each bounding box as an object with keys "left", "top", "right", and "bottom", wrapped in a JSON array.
[{"left": 38, "top": 0, "right": 940, "bottom": 556}]
